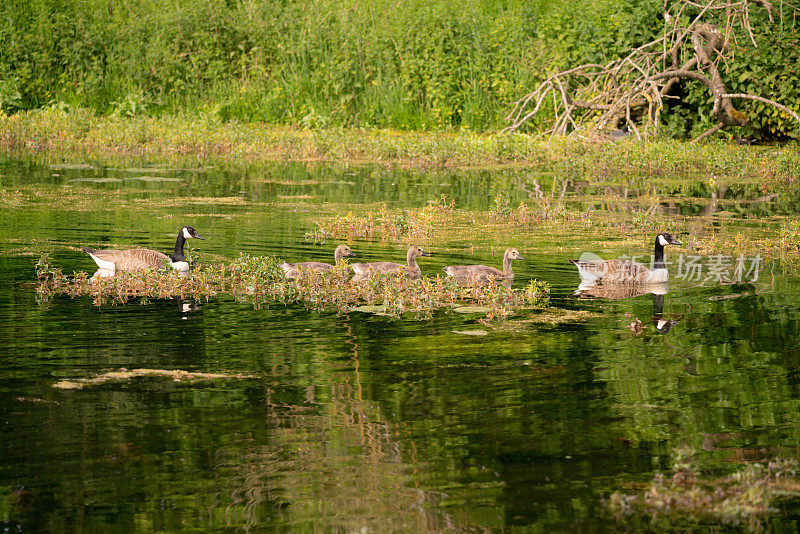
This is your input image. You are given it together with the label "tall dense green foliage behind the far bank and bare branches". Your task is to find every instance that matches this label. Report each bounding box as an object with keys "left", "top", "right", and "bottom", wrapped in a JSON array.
[{"left": 0, "top": 0, "right": 798, "bottom": 140}]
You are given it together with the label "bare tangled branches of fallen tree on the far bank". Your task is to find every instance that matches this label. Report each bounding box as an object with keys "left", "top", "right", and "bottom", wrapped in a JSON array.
[{"left": 504, "top": 0, "right": 800, "bottom": 141}]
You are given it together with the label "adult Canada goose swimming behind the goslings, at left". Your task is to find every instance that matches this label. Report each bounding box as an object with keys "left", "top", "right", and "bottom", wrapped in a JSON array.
[{"left": 82, "top": 226, "right": 205, "bottom": 272}]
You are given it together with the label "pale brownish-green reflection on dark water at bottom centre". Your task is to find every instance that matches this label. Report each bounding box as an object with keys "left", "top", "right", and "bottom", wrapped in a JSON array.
[{"left": 225, "top": 325, "right": 467, "bottom": 532}]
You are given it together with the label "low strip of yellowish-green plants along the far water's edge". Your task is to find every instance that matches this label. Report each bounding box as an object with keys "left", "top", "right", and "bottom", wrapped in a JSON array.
[{"left": 0, "top": 109, "right": 800, "bottom": 184}]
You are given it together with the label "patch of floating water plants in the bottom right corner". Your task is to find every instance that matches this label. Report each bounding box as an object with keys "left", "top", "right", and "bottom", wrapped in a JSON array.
[{"left": 605, "top": 447, "right": 800, "bottom": 529}]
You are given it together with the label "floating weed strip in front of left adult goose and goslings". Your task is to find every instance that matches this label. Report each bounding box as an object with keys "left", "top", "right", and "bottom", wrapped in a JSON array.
[{"left": 36, "top": 254, "right": 549, "bottom": 320}]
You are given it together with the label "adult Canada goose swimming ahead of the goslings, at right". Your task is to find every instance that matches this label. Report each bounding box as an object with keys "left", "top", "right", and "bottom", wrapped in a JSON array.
[{"left": 569, "top": 232, "right": 683, "bottom": 284}]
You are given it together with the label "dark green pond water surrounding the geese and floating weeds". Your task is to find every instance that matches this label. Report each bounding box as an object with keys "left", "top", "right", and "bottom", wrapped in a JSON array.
[{"left": 0, "top": 155, "right": 800, "bottom": 532}]
